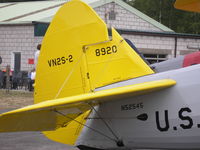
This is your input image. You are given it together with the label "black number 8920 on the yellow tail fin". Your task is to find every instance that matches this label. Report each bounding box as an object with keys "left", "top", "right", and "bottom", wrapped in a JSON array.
[{"left": 95, "top": 45, "right": 117, "bottom": 56}]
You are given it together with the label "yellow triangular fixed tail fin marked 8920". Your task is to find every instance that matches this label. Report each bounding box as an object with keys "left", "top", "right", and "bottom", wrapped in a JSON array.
[{"left": 86, "top": 28, "right": 154, "bottom": 89}]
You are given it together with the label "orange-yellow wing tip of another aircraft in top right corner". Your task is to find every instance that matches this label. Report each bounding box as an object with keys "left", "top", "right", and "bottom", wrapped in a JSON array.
[{"left": 174, "top": 0, "right": 200, "bottom": 12}]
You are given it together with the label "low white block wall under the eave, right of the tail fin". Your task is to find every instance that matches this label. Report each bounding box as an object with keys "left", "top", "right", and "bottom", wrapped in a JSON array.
[{"left": 122, "top": 34, "right": 200, "bottom": 58}]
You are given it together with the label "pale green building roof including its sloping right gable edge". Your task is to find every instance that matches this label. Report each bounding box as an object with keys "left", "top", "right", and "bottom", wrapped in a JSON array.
[{"left": 0, "top": 0, "right": 173, "bottom": 32}]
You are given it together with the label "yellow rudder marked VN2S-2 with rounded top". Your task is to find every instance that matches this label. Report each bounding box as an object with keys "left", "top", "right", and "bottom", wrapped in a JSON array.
[{"left": 34, "top": 0, "right": 108, "bottom": 103}]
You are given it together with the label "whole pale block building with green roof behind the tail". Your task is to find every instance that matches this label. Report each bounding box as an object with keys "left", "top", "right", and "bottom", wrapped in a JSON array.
[{"left": 0, "top": 0, "right": 200, "bottom": 71}]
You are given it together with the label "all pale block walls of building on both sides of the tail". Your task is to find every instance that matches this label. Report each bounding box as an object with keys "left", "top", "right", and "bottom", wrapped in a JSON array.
[{"left": 0, "top": 3, "right": 200, "bottom": 71}]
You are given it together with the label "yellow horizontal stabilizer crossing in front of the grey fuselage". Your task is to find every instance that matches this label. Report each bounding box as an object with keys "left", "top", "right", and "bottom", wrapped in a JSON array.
[{"left": 0, "top": 79, "right": 176, "bottom": 132}]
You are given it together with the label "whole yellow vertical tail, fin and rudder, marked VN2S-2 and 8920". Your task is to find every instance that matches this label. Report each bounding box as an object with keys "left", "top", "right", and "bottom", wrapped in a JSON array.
[{"left": 34, "top": 0, "right": 153, "bottom": 145}]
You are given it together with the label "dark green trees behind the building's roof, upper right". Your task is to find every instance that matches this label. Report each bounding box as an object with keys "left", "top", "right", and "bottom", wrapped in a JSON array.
[{"left": 124, "top": 0, "right": 200, "bottom": 34}]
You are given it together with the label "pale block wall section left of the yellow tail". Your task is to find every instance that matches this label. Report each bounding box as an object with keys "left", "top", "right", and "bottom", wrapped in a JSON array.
[{"left": 0, "top": 25, "right": 42, "bottom": 70}]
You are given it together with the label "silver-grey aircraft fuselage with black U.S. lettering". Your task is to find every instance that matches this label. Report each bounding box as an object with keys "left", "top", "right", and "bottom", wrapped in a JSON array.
[{"left": 76, "top": 65, "right": 200, "bottom": 149}]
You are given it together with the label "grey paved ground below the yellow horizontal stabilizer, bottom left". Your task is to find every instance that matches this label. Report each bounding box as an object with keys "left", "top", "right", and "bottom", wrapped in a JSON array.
[{"left": 0, "top": 109, "right": 77, "bottom": 150}]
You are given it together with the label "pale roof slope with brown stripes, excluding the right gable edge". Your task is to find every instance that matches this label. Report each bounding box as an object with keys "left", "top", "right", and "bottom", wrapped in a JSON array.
[{"left": 0, "top": 0, "right": 100, "bottom": 22}]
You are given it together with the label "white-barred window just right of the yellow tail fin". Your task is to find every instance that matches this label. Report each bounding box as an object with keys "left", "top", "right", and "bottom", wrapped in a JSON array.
[{"left": 143, "top": 54, "right": 167, "bottom": 64}]
